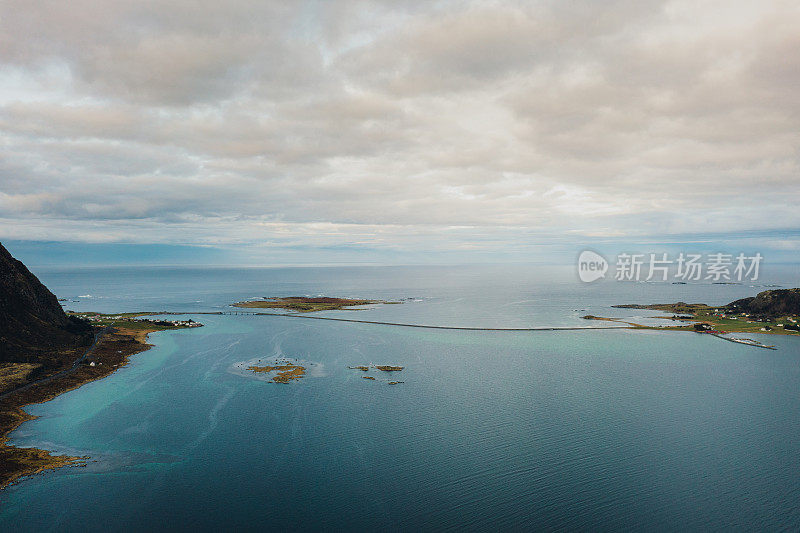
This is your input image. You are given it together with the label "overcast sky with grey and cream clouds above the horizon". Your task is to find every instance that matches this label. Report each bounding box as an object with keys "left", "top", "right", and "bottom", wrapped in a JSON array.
[{"left": 0, "top": 0, "right": 800, "bottom": 264}]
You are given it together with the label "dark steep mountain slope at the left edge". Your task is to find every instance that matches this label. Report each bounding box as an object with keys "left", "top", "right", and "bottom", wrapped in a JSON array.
[{"left": 0, "top": 243, "right": 93, "bottom": 368}]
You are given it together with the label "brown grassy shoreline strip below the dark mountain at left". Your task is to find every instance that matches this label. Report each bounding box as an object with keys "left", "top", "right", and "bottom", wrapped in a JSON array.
[{"left": 0, "top": 320, "right": 174, "bottom": 490}]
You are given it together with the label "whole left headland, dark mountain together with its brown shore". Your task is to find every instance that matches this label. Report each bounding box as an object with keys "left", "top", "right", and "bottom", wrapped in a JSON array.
[{"left": 0, "top": 244, "right": 200, "bottom": 489}]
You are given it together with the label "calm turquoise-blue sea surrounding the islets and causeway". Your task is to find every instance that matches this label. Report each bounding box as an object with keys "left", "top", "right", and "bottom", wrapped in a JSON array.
[{"left": 0, "top": 268, "right": 800, "bottom": 531}]
